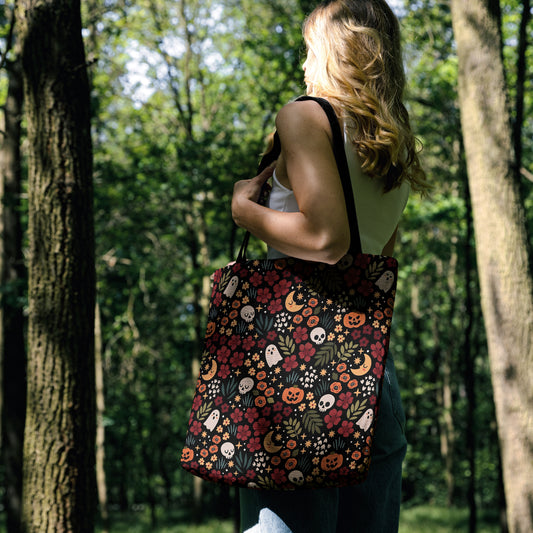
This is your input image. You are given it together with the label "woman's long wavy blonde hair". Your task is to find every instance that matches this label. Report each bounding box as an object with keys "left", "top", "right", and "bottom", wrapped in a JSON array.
[{"left": 303, "top": 0, "right": 430, "bottom": 192}]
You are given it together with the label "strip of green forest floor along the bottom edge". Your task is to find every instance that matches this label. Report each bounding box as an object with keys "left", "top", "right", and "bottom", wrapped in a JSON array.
[{"left": 90, "top": 505, "right": 500, "bottom": 533}]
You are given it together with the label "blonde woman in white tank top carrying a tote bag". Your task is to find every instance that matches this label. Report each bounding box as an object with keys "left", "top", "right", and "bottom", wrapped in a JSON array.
[{"left": 232, "top": 0, "right": 428, "bottom": 533}]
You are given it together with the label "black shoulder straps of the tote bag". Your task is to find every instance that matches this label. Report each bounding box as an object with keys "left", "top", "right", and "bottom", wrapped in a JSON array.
[{"left": 237, "top": 96, "right": 362, "bottom": 261}]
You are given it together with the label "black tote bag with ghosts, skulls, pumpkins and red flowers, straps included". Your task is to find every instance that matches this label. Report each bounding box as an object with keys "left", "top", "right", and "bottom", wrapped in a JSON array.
[{"left": 181, "top": 97, "right": 398, "bottom": 490}]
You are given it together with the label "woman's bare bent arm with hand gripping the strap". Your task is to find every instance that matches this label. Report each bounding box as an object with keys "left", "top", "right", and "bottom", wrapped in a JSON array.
[{"left": 232, "top": 101, "right": 350, "bottom": 264}]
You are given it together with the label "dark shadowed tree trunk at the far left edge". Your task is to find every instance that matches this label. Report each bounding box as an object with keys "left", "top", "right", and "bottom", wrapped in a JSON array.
[{"left": 0, "top": 57, "right": 26, "bottom": 533}]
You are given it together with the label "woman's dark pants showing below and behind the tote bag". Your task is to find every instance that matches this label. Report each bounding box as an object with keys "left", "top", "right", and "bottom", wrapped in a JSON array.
[{"left": 240, "top": 356, "right": 407, "bottom": 533}]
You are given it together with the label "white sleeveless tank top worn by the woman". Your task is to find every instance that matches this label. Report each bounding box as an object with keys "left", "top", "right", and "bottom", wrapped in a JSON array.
[{"left": 268, "top": 132, "right": 410, "bottom": 259}]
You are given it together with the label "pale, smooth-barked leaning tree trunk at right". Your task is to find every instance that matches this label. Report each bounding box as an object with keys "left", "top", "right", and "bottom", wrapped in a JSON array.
[{"left": 451, "top": 0, "right": 533, "bottom": 533}]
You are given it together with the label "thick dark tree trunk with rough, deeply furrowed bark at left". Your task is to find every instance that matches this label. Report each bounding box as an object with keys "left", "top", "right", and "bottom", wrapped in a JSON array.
[{"left": 17, "top": 0, "right": 96, "bottom": 533}]
